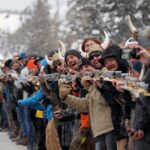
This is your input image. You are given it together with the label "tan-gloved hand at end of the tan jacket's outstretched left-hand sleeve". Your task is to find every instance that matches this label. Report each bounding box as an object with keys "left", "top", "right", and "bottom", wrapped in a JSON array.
[{"left": 59, "top": 84, "right": 72, "bottom": 98}]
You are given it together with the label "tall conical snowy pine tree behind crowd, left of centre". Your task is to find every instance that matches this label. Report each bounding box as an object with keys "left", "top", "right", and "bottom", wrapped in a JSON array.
[{"left": 26, "top": 0, "right": 51, "bottom": 54}]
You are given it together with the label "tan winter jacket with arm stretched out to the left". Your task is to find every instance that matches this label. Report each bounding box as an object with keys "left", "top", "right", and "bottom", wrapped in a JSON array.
[{"left": 64, "top": 85, "right": 114, "bottom": 137}]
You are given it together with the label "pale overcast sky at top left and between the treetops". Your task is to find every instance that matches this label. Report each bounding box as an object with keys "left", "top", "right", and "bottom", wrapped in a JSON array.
[{"left": 0, "top": 0, "right": 68, "bottom": 13}]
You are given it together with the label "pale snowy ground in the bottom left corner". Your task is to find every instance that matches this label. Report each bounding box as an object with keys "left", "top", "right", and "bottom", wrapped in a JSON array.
[{"left": 0, "top": 132, "right": 27, "bottom": 150}]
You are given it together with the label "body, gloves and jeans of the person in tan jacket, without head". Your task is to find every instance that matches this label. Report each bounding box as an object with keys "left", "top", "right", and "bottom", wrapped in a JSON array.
[{"left": 59, "top": 59, "right": 116, "bottom": 150}]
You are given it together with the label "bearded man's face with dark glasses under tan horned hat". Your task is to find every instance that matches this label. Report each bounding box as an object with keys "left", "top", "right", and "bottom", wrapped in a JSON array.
[{"left": 90, "top": 55, "right": 102, "bottom": 69}]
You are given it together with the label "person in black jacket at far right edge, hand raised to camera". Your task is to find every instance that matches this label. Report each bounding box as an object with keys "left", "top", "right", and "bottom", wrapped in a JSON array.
[{"left": 132, "top": 46, "right": 150, "bottom": 150}]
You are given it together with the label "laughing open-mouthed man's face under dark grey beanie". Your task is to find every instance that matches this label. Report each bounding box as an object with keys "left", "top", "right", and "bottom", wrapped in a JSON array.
[{"left": 66, "top": 55, "right": 79, "bottom": 70}]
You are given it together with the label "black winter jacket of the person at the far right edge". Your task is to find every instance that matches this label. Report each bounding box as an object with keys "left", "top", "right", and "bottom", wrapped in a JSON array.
[{"left": 133, "top": 69, "right": 150, "bottom": 150}]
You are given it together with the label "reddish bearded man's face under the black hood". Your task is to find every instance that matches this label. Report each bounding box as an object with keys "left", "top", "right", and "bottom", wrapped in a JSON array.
[{"left": 104, "top": 57, "right": 118, "bottom": 71}]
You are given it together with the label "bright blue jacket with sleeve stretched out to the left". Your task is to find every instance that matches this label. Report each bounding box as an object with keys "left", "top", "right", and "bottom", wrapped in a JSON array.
[{"left": 18, "top": 88, "right": 53, "bottom": 120}]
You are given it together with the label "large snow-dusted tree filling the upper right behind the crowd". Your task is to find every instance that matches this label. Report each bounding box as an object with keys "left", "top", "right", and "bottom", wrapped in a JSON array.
[{"left": 67, "top": 0, "right": 150, "bottom": 43}]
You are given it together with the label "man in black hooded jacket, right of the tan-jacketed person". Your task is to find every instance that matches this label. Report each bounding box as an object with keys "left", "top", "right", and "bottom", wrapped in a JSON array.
[{"left": 100, "top": 45, "right": 132, "bottom": 150}]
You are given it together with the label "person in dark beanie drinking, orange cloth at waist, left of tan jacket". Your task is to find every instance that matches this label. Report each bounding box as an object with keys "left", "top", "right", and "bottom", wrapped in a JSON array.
[{"left": 70, "top": 58, "right": 95, "bottom": 150}]
